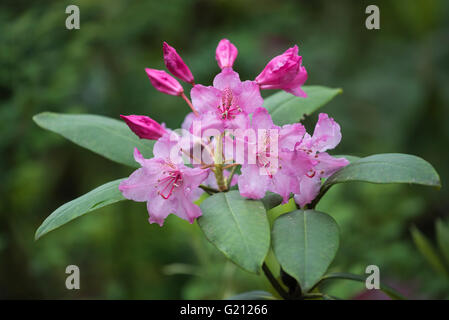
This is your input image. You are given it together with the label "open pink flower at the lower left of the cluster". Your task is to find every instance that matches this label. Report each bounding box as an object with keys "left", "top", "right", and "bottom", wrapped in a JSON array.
[{"left": 119, "top": 135, "right": 209, "bottom": 226}]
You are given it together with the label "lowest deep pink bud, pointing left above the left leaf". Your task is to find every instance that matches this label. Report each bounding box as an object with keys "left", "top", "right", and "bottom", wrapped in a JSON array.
[{"left": 120, "top": 115, "right": 167, "bottom": 140}]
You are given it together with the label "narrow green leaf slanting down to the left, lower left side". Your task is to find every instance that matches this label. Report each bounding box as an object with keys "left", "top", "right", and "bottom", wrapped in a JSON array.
[{"left": 35, "top": 179, "right": 125, "bottom": 240}]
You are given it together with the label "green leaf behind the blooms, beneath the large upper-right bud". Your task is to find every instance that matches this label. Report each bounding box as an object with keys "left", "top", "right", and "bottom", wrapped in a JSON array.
[{"left": 263, "top": 86, "right": 342, "bottom": 126}]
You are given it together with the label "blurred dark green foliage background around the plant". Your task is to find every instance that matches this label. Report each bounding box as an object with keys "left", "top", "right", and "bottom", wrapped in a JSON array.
[{"left": 0, "top": 0, "right": 449, "bottom": 299}]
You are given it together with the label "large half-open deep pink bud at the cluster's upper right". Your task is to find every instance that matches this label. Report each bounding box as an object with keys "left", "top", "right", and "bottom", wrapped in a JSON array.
[{"left": 255, "top": 45, "right": 307, "bottom": 97}]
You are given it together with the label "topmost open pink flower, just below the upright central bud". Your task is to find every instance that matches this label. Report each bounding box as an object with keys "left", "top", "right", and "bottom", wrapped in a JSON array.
[{"left": 190, "top": 68, "right": 263, "bottom": 130}]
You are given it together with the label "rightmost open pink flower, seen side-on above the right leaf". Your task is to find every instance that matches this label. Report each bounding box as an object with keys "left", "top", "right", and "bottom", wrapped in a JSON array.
[{"left": 295, "top": 113, "right": 349, "bottom": 207}]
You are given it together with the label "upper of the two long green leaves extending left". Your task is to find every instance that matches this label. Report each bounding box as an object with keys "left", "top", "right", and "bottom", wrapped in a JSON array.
[{"left": 33, "top": 112, "right": 154, "bottom": 167}]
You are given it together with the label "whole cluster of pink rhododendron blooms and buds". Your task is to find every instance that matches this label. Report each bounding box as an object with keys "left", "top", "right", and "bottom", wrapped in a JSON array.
[{"left": 119, "top": 39, "right": 348, "bottom": 226}]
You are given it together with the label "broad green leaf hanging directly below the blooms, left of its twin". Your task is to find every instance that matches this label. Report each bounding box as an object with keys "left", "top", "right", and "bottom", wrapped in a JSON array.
[{"left": 198, "top": 190, "right": 270, "bottom": 273}]
